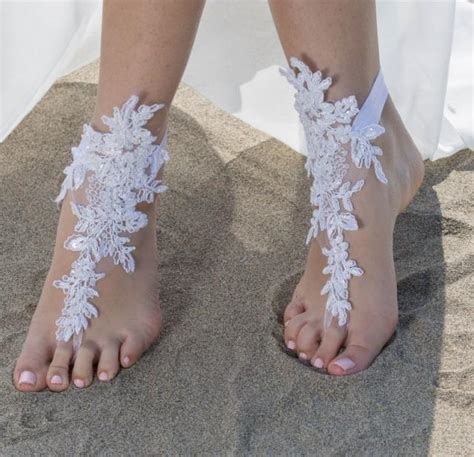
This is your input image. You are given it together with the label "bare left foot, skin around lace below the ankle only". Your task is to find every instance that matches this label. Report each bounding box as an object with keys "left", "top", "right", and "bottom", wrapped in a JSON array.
[{"left": 13, "top": 180, "right": 165, "bottom": 392}]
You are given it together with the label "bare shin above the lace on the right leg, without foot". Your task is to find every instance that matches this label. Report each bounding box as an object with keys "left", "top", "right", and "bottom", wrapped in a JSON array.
[{"left": 269, "top": 0, "right": 380, "bottom": 106}]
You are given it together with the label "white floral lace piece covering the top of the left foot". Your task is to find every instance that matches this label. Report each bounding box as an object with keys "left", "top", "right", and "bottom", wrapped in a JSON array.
[{"left": 53, "top": 95, "right": 169, "bottom": 341}]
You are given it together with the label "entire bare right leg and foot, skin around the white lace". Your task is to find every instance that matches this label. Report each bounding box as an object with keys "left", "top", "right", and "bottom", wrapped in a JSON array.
[{"left": 270, "top": 0, "right": 423, "bottom": 375}]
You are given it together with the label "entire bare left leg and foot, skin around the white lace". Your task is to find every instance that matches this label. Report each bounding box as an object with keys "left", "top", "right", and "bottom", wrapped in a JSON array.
[{"left": 14, "top": 0, "right": 204, "bottom": 391}]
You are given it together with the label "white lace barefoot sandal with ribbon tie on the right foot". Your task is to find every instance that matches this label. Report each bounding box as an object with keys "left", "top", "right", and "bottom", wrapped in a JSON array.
[{"left": 280, "top": 57, "right": 388, "bottom": 328}]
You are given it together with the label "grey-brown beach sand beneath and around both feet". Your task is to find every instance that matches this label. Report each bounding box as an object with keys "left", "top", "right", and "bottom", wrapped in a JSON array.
[{"left": 0, "top": 61, "right": 474, "bottom": 456}]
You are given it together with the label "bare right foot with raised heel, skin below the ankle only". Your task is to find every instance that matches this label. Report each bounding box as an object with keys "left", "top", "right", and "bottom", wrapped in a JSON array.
[{"left": 284, "top": 98, "right": 424, "bottom": 375}]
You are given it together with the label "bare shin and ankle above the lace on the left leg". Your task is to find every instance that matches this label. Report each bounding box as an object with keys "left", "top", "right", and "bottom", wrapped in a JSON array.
[{"left": 92, "top": 0, "right": 205, "bottom": 140}]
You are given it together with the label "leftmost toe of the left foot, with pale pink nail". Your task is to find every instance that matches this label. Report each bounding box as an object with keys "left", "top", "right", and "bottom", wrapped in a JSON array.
[{"left": 13, "top": 343, "right": 51, "bottom": 392}]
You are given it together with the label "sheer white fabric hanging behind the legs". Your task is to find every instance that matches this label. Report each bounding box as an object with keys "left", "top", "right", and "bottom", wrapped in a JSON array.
[{"left": 0, "top": 0, "right": 474, "bottom": 160}]
